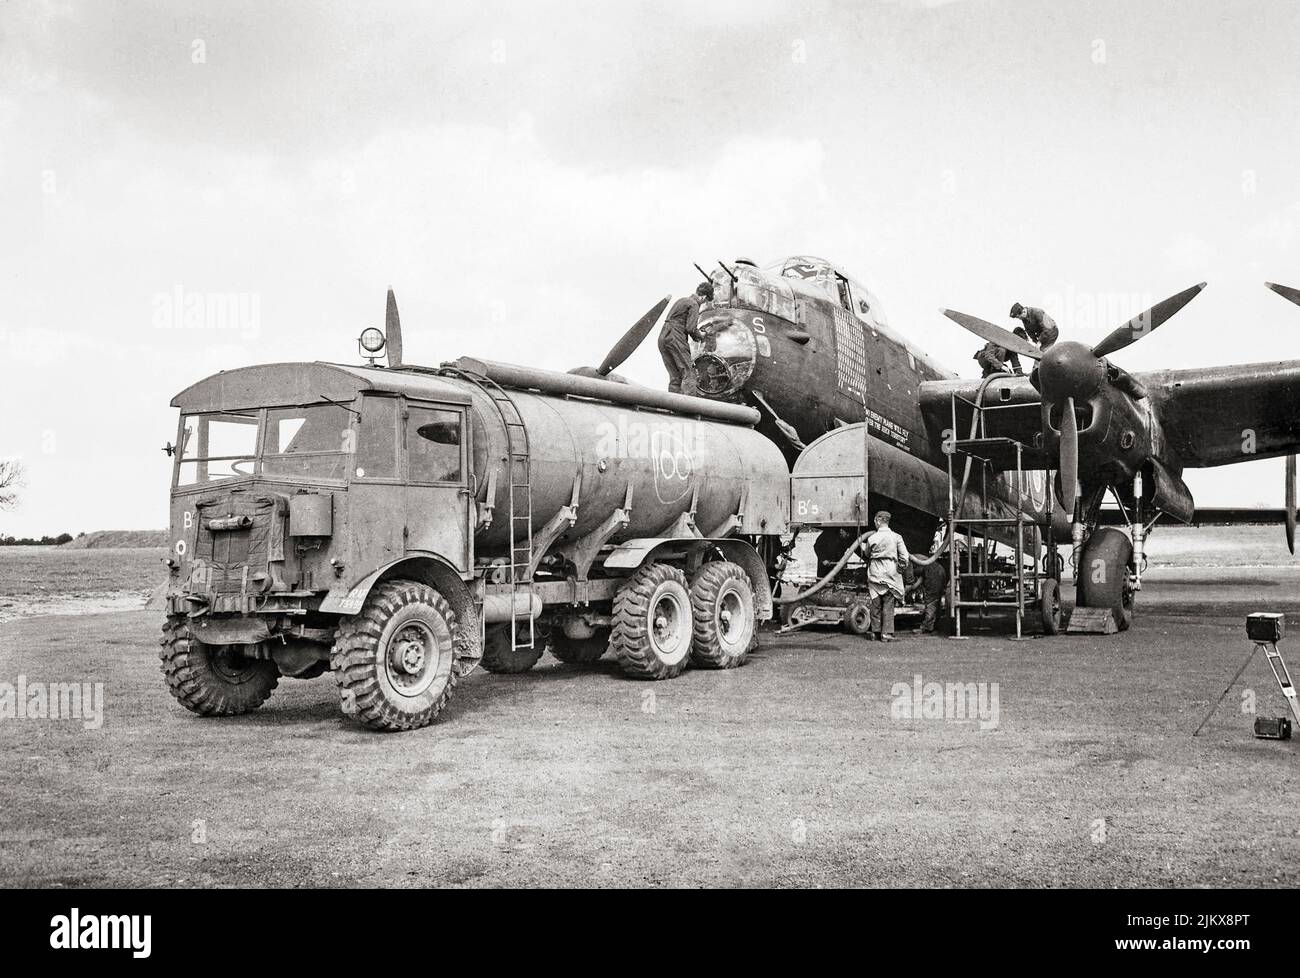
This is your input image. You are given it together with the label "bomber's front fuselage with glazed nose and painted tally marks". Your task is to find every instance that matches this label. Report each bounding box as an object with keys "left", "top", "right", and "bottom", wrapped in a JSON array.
[{"left": 696, "top": 259, "right": 1049, "bottom": 551}]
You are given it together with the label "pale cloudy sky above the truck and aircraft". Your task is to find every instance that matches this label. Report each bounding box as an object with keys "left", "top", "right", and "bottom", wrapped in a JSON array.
[{"left": 0, "top": 0, "right": 1300, "bottom": 535}]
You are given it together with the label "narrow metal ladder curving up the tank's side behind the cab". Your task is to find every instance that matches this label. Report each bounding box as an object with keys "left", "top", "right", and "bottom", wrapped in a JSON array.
[{"left": 441, "top": 367, "right": 534, "bottom": 649}]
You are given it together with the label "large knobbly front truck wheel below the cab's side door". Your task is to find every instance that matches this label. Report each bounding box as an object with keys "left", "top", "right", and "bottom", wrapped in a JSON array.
[{"left": 330, "top": 580, "right": 472, "bottom": 731}]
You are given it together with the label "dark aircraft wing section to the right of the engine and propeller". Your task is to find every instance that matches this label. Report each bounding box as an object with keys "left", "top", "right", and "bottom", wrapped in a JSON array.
[{"left": 1135, "top": 360, "right": 1300, "bottom": 468}]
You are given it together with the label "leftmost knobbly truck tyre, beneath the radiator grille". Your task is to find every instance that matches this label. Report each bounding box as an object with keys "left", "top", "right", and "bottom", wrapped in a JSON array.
[{"left": 159, "top": 616, "right": 280, "bottom": 717}]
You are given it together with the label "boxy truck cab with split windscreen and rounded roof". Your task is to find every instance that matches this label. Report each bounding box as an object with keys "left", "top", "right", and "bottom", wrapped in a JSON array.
[{"left": 169, "top": 364, "right": 473, "bottom": 613}]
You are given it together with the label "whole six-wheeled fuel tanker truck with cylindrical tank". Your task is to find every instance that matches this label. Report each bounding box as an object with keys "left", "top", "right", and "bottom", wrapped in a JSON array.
[{"left": 161, "top": 359, "right": 789, "bottom": 731}]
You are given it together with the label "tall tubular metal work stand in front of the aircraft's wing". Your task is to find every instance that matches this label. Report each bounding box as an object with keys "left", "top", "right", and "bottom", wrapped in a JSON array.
[{"left": 946, "top": 377, "right": 1054, "bottom": 639}]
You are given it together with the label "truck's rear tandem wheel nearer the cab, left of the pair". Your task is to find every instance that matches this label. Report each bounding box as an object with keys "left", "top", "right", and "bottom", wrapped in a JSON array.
[{"left": 610, "top": 563, "right": 694, "bottom": 679}]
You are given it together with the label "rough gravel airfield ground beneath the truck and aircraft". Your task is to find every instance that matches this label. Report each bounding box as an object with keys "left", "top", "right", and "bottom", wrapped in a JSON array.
[{"left": 0, "top": 556, "right": 1300, "bottom": 887}]
